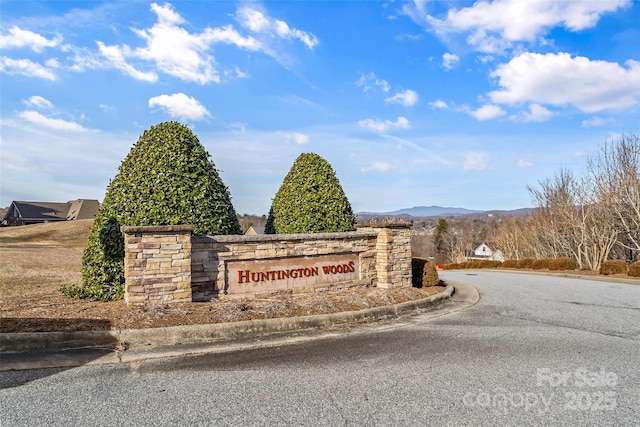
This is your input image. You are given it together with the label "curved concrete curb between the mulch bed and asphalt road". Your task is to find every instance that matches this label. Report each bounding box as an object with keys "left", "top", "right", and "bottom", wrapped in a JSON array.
[{"left": 0, "top": 285, "right": 455, "bottom": 360}]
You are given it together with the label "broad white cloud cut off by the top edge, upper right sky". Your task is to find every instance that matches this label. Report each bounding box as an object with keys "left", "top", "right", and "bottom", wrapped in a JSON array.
[{"left": 426, "top": 0, "right": 631, "bottom": 53}]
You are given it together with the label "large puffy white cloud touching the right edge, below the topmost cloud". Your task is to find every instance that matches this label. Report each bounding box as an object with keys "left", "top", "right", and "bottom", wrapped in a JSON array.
[{"left": 489, "top": 53, "right": 640, "bottom": 113}]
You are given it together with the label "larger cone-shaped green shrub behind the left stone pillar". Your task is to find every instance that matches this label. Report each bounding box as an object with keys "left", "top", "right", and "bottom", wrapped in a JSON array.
[{"left": 76, "top": 122, "right": 242, "bottom": 300}]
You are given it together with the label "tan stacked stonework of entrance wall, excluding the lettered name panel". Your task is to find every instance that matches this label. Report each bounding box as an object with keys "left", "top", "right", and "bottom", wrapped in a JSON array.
[{"left": 122, "top": 225, "right": 411, "bottom": 304}]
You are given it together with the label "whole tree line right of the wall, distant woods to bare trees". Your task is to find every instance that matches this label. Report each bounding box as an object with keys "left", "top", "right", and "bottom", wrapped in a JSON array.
[{"left": 412, "top": 133, "right": 640, "bottom": 271}]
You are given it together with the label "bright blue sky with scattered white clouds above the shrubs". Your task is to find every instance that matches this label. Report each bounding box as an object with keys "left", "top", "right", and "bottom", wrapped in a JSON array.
[{"left": 0, "top": 0, "right": 640, "bottom": 215}]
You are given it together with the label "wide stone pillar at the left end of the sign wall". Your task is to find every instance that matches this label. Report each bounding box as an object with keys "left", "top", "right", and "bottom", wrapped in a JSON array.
[{"left": 121, "top": 225, "right": 194, "bottom": 304}]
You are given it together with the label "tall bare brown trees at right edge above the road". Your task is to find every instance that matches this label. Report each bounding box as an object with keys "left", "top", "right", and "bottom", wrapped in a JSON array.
[{"left": 495, "top": 134, "right": 640, "bottom": 270}]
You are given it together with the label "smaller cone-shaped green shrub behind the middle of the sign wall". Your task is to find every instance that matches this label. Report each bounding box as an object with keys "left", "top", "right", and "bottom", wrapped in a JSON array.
[{"left": 265, "top": 153, "right": 356, "bottom": 234}]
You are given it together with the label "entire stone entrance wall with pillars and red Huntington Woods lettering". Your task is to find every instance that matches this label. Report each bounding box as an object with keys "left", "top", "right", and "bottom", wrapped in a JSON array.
[{"left": 122, "top": 225, "right": 411, "bottom": 304}]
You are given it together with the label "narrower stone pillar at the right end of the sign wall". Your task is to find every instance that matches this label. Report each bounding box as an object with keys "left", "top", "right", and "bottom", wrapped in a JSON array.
[{"left": 371, "top": 224, "right": 411, "bottom": 289}]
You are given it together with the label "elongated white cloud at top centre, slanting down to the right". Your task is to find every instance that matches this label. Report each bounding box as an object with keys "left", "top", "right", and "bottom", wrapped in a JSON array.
[{"left": 236, "top": 5, "right": 319, "bottom": 49}]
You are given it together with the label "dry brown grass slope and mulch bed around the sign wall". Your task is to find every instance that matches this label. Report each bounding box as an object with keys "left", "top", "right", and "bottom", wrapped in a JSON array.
[{"left": 0, "top": 221, "right": 443, "bottom": 332}]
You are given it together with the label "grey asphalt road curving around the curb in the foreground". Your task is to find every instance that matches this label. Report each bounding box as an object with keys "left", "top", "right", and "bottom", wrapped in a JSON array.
[{"left": 0, "top": 270, "right": 640, "bottom": 426}]
